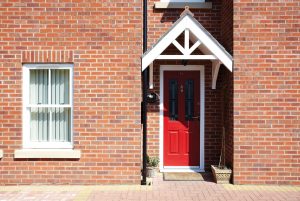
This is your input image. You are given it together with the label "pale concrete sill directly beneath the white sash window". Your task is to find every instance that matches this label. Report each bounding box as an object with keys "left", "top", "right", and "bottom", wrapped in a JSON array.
[{"left": 15, "top": 149, "right": 81, "bottom": 159}]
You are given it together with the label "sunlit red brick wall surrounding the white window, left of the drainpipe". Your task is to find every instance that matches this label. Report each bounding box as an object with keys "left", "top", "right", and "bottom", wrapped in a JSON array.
[{"left": 0, "top": 0, "right": 142, "bottom": 184}]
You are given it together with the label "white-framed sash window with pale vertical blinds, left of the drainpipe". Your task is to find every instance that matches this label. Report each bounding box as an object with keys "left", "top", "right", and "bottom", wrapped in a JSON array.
[{"left": 23, "top": 64, "right": 73, "bottom": 148}]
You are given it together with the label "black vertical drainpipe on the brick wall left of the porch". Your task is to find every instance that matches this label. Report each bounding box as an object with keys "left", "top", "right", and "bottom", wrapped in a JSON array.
[{"left": 142, "top": 0, "right": 148, "bottom": 185}]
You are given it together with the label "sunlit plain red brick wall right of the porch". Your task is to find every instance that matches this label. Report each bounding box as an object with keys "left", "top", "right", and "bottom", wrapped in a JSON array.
[{"left": 234, "top": 0, "right": 300, "bottom": 185}]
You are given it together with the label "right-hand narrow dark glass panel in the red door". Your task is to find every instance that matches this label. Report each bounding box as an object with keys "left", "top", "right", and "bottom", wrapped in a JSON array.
[{"left": 185, "top": 80, "right": 194, "bottom": 120}]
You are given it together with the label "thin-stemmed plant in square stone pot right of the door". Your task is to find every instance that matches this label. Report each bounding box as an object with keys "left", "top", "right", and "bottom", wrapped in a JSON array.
[{"left": 211, "top": 127, "right": 232, "bottom": 184}]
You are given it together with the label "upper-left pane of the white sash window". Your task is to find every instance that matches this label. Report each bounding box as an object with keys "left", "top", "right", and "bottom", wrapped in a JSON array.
[{"left": 29, "top": 69, "right": 48, "bottom": 104}]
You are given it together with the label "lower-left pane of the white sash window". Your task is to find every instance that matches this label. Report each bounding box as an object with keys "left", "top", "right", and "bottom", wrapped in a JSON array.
[{"left": 30, "top": 108, "right": 49, "bottom": 142}]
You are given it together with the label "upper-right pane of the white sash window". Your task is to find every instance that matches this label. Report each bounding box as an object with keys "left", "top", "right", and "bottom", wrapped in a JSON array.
[{"left": 51, "top": 69, "right": 70, "bottom": 105}]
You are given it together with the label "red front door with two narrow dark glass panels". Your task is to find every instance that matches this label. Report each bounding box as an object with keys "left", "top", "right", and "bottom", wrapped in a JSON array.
[{"left": 164, "top": 71, "right": 200, "bottom": 166}]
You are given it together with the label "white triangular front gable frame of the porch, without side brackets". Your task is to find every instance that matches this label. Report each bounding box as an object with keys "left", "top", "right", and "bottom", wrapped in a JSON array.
[{"left": 142, "top": 14, "right": 233, "bottom": 72}]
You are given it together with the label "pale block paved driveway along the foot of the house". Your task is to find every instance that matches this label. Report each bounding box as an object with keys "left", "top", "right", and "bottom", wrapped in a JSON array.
[{"left": 0, "top": 175, "right": 300, "bottom": 201}]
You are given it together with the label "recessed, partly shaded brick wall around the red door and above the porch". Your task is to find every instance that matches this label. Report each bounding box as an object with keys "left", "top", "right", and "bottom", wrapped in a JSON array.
[{"left": 148, "top": 0, "right": 222, "bottom": 169}]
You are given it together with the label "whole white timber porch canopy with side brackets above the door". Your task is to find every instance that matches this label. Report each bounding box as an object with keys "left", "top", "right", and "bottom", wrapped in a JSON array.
[{"left": 142, "top": 8, "right": 232, "bottom": 89}]
